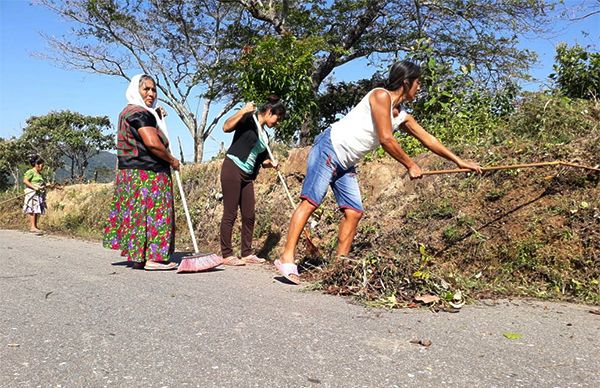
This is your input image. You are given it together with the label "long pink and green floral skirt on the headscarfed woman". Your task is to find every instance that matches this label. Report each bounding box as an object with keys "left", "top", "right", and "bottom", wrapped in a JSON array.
[{"left": 104, "top": 170, "right": 175, "bottom": 262}]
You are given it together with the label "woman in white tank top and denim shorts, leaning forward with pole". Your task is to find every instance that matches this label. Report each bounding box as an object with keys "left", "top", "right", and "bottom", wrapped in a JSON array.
[{"left": 275, "top": 61, "right": 481, "bottom": 284}]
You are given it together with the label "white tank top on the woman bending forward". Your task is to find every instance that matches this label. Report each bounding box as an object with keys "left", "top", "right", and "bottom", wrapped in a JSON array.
[{"left": 331, "top": 88, "right": 407, "bottom": 169}]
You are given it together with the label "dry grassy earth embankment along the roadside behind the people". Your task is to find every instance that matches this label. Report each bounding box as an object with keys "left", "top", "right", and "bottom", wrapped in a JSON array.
[{"left": 0, "top": 96, "right": 600, "bottom": 307}]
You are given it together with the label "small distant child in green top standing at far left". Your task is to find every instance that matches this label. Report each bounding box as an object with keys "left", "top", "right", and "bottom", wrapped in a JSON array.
[{"left": 23, "top": 155, "right": 46, "bottom": 234}]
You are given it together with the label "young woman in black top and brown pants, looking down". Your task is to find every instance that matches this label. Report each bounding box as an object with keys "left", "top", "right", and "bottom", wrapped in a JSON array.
[{"left": 220, "top": 96, "right": 285, "bottom": 266}]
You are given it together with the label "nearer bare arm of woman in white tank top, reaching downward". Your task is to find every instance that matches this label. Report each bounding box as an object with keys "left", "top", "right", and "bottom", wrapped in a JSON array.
[{"left": 369, "top": 90, "right": 421, "bottom": 178}]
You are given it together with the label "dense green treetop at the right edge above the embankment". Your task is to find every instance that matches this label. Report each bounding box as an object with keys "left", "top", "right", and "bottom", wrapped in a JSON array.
[{"left": 550, "top": 43, "right": 600, "bottom": 100}]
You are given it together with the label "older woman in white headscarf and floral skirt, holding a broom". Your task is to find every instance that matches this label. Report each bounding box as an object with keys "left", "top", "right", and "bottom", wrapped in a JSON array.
[{"left": 104, "top": 74, "right": 179, "bottom": 270}]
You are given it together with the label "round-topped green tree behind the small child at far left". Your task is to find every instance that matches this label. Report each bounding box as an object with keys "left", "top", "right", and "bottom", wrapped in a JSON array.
[{"left": 21, "top": 111, "right": 114, "bottom": 179}]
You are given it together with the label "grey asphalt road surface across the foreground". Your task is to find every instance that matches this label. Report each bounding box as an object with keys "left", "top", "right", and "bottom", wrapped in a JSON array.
[{"left": 0, "top": 230, "right": 600, "bottom": 387}]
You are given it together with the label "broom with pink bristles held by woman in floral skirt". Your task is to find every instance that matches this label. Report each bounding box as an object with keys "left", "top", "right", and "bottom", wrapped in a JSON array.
[{"left": 160, "top": 110, "right": 223, "bottom": 273}]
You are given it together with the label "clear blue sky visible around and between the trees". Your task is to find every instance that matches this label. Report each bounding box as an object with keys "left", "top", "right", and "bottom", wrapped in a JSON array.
[{"left": 0, "top": 0, "right": 600, "bottom": 160}]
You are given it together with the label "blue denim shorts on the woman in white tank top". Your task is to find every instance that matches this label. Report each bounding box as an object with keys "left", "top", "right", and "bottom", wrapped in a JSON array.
[{"left": 300, "top": 129, "right": 364, "bottom": 213}]
